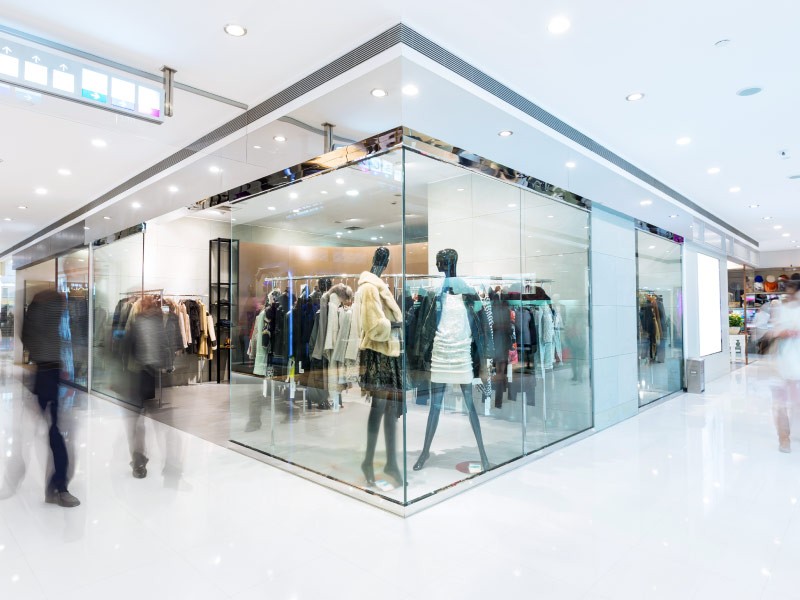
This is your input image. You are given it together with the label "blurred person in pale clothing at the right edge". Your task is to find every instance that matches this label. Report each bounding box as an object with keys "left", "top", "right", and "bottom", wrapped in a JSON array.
[{"left": 767, "top": 281, "right": 800, "bottom": 452}]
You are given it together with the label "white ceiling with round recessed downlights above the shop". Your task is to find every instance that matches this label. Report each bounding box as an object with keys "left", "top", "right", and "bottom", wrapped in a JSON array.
[{"left": 0, "top": 0, "right": 800, "bottom": 252}]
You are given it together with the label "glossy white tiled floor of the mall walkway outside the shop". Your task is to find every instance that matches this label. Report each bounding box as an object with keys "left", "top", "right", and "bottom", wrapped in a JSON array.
[{"left": 0, "top": 361, "right": 800, "bottom": 600}]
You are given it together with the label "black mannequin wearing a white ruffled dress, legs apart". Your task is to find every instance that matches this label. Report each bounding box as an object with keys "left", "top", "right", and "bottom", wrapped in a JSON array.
[{"left": 414, "top": 248, "right": 492, "bottom": 471}]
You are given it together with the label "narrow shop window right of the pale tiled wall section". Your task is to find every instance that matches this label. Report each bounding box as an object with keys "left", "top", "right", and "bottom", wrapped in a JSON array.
[{"left": 636, "top": 231, "right": 683, "bottom": 406}]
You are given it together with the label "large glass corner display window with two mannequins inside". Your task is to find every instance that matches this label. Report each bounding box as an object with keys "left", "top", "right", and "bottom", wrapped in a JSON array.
[{"left": 230, "top": 130, "right": 592, "bottom": 505}]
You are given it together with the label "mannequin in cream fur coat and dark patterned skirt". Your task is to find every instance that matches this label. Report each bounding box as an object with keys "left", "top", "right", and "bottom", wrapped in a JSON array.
[{"left": 356, "top": 246, "right": 403, "bottom": 484}]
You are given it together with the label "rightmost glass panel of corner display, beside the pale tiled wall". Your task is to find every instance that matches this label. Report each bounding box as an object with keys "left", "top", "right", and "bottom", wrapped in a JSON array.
[{"left": 511, "top": 191, "right": 593, "bottom": 452}]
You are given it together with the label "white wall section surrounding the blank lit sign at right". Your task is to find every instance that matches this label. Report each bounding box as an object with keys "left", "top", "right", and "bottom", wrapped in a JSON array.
[{"left": 683, "top": 242, "right": 731, "bottom": 382}]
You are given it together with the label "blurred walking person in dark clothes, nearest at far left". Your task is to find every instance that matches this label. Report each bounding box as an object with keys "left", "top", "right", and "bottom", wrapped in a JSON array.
[{"left": 22, "top": 290, "right": 80, "bottom": 508}]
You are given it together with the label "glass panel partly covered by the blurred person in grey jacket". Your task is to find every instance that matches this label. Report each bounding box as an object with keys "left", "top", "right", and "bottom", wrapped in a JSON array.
[{"left": 92, "top": 233, "right": 144, "bottom": 407}]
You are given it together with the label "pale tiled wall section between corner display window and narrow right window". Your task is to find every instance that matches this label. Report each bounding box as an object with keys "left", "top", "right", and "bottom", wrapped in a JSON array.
[{"left": 591, "top": 205, "right": 639, "bottom": 429}]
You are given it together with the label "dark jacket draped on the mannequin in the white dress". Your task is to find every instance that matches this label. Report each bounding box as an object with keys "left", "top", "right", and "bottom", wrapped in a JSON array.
[{"left": 407, "top": 289, "right": 494, "bottom": 379}]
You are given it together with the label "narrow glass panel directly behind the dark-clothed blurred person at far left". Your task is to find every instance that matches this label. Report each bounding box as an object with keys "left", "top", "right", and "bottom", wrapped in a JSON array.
[{"left": 56, "top": 248, "right": 89, "bottom": 389}]
